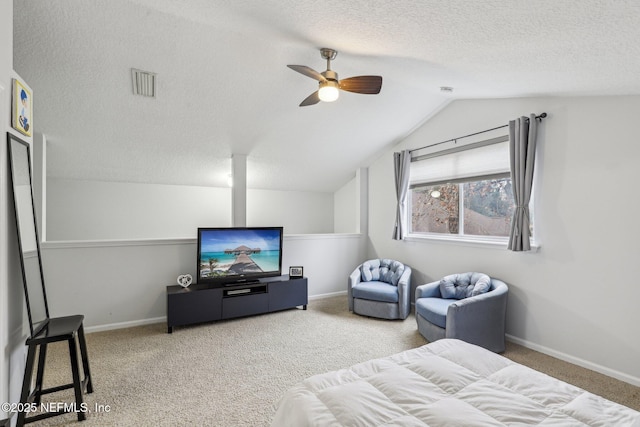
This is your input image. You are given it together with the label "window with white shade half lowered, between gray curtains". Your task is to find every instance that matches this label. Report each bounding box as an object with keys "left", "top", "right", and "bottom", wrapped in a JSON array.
[{"left": 407, "top": 135, "right": 528, "bottom": 241}]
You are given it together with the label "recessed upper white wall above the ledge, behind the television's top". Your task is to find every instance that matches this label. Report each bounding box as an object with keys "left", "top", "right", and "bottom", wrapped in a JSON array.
[{"left": 46, "top": 177, "right": 333, "bottom": 241}]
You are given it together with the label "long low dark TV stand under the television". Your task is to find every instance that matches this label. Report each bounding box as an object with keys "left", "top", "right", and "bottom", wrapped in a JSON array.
[{"left": 167, "top": 276, "right": 308, "bottom": 333}]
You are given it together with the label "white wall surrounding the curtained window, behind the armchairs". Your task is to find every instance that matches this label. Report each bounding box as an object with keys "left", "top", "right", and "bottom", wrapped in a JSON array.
[{"left": 368, "top": 96, "right": 640, "bottom": 385}]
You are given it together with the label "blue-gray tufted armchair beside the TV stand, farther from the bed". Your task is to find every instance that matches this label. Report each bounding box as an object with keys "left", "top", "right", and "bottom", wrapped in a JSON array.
[{"left": 347, "top": 259, "right": 411, "bottom": 319}]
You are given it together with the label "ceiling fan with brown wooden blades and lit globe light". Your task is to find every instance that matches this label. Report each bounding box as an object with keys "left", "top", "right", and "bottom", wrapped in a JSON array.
[{"left": 287, "top": 48, "right": 382, "bottom": 107}]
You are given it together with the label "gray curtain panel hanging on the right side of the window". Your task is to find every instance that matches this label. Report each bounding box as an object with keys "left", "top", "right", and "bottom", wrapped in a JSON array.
[{"left": 508, "top": 114, "right": 538, "bottom": 251}]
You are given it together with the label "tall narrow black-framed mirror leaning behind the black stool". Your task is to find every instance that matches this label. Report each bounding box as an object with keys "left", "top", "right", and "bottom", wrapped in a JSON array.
[{"left": 7, "top": 133, "right": 49, "bottom": 336}]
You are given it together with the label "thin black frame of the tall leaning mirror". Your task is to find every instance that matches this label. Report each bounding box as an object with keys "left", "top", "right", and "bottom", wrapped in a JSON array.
[{"left": 7, "top": 132, "right": 49, "bottom": 337}]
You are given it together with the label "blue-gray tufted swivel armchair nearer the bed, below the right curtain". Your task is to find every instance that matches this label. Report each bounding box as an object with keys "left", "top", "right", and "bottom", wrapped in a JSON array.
[{"left": 415, "top": 273, "right": 509, "bottom": 353}]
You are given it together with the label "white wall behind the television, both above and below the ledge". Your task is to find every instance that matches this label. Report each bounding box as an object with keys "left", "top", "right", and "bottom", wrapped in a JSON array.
[{"left": 42, "top": 171, "right": 358, "bottom": 330}]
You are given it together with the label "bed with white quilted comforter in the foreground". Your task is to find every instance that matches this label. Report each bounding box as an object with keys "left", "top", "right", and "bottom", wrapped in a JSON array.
[{"left": 272, "top": 339, "right": 640, "bottom": 427}]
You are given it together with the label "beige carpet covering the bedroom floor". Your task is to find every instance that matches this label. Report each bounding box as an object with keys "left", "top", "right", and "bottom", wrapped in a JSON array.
[{"left": 26, "top": 296, "right": 640, "bottom": 427}]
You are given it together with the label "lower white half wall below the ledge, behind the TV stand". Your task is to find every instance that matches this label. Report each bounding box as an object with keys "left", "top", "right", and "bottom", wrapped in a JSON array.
[{"left": 42, "top": 234, "right": 365, "bottom": 330}]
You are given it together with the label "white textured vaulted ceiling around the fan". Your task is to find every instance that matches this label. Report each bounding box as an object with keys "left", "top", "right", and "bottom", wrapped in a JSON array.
[{"left": 14, "top": 0, "right": 640, "bottom": 191}]
